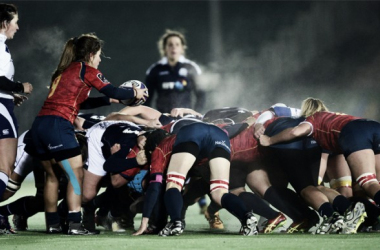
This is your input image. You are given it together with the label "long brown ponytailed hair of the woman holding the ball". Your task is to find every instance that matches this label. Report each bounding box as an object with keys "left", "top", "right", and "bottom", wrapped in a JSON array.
[{"left": 51, "top": 33, "right": 104, "bottom": 82}]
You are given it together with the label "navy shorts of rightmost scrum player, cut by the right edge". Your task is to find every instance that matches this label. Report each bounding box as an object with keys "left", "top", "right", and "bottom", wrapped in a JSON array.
[{"left": 339, "top": 119, "right": 380, "bottom": 157}]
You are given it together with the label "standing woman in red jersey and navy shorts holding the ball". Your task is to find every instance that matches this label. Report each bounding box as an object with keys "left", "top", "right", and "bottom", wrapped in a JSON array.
[{"left": 25, "top": 34, "right": 144, "bottom": 235}]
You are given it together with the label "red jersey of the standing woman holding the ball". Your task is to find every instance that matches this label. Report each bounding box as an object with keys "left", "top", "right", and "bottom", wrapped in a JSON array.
[{"left": 38, "top": 62, "right": 110, "bottom": 123}]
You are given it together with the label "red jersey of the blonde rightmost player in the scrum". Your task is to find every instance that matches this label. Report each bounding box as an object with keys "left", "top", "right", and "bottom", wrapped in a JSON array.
[{"left": 300, "top": 112, "right": 362, "bottom": 153}]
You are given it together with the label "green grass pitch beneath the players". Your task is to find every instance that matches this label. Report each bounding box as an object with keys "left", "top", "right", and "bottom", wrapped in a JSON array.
[{"left": 0, "top": 182, "right": 380, "bottom": 250}]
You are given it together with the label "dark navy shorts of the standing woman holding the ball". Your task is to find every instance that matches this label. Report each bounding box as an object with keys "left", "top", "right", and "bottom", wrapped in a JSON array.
[{"left": 30, "top": 115, "right": 81, "bottom": 161}]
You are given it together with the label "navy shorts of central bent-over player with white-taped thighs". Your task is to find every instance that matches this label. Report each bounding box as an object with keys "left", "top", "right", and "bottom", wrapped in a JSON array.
[{"left": 173, "top": 122, "right": 231, "bottom": 159}]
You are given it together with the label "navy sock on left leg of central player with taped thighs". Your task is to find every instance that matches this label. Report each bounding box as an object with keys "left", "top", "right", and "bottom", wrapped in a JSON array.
[{"left": 164, "top": 188, "right": 183, "bottom": 222}]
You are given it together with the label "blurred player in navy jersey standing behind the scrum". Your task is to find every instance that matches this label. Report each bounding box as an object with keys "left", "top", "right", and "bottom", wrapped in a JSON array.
[{"left": 145, "top": 30, "right": 205, "bottom": 113}]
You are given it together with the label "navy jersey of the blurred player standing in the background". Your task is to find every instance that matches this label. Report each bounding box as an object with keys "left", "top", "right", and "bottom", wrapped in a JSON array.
[{"left": 145, "top": 57, "right": 204, "bottom": 113}]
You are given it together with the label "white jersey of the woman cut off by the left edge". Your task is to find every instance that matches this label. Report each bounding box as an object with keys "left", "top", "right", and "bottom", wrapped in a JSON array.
[{"left": 0, "top": 34, "right": 15, "bottom": 99}]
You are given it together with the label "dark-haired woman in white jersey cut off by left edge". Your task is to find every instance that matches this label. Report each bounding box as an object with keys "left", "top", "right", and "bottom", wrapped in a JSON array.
[{"left": 0, "top": 3, "right": 33, "bottom": 234}]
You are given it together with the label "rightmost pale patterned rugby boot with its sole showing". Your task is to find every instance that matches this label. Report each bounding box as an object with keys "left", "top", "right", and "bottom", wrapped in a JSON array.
[{"left": 342, "top": 202, "right": 367, "bottom": 234}]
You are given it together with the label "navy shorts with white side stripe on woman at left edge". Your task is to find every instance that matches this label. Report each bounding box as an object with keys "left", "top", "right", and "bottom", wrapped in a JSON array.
[{"left": 0, "top": 98, "right": 18, "bottom": 139}]
